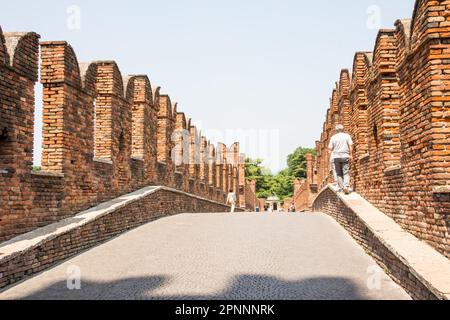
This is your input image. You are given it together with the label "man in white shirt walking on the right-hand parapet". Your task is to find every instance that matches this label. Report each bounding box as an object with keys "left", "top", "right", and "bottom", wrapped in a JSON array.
[{"left": 328, "top": 124, "right": 353, "bottom": 194}]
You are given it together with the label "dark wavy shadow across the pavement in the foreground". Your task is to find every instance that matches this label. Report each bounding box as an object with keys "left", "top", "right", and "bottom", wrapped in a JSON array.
[{"left": 10, "top": 275, "right": 367, "bottom": 300}]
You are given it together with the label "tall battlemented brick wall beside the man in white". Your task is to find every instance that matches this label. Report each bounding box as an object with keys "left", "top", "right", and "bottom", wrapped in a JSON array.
[{"left": 314, "top": 0, "right": 450, "bottom": 257}]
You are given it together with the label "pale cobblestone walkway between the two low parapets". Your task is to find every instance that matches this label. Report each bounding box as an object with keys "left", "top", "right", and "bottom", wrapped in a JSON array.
[{"left": 0, "top": 214, "right": 409, "bottom": 299}]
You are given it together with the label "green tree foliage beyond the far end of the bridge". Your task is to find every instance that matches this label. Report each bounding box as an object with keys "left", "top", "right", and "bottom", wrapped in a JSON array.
[{"left": 245, "top": 148, "right": 314, "bottom": 201}]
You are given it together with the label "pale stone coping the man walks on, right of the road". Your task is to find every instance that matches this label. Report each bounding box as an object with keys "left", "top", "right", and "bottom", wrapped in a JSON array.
[{"left": 316, "top": 185, "right": 450, "bottom": 300}]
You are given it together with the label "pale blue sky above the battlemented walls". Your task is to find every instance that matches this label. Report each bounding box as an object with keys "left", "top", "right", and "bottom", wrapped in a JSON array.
[{"left": 0, "top": 0, "right": 414, "bottom": 171}]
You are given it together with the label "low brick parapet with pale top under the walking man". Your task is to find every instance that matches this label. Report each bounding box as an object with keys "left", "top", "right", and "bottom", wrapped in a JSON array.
[{"left": 313, "top": 186, "right": 450, "bottom": 300}]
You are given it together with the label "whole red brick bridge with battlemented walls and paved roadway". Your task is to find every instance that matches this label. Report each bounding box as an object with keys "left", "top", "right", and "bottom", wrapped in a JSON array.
[{"left": 0, "top": 0, "right": 450, "bottom": 299}]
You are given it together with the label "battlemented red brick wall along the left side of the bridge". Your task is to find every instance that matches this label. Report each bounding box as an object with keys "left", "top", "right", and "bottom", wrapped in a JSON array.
[{"left": 0, "top": 29, "right": 246, "bottom": 242}]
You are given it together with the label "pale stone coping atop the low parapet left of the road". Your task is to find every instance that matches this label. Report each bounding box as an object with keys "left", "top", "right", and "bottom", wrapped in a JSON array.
[{"left": 0, "top": 186, "right": 232, "bottom": 264}]
